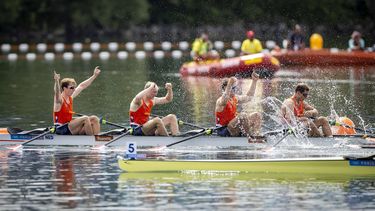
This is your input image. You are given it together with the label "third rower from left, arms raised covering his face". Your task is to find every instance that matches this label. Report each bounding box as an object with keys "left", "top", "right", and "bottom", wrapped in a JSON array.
[{"left": 215, "top": 72, "right": 262, "bottom": 140}]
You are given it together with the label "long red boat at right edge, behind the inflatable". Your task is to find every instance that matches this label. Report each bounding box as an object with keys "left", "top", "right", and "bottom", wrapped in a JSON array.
[{"left": 272, "top": 49, "right": 375, "bottom": 66}]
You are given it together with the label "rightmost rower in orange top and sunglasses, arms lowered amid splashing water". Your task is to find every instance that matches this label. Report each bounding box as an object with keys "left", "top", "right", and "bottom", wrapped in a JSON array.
[{"left": 281, "top": 83, "right": 332, "bottom": 137}]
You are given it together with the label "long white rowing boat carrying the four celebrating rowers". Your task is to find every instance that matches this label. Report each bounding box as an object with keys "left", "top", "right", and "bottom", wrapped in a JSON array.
[{"left": 0, "top": 129, "right": 375, "bottom": 148}]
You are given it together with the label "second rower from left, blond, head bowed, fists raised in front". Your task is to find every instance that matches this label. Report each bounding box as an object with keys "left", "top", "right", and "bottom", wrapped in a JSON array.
[{"left": 129, "top": 81, "right": 180, "bottom": 136}]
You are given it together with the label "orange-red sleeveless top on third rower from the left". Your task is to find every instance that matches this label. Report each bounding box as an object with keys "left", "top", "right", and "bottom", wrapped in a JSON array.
[{"left": 216, "top": 96, "right": 238, "bottom": 126}]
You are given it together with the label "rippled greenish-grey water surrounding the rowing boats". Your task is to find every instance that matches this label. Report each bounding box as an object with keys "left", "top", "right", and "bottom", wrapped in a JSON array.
[{"left": 0, "top": 59, "right": 375, "bottom": 210}]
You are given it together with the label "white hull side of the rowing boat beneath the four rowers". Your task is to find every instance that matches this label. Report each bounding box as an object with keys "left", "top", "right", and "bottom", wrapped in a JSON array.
[{"left": 0, "top": 134, "right": 373, "bottom": 148}]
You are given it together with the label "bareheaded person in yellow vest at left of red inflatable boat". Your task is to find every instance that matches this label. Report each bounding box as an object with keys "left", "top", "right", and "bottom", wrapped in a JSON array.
[{"left": 192, "top": 33, "right": 218, "bottom": 61}]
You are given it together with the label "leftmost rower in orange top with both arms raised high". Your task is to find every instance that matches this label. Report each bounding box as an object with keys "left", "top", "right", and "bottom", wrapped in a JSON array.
[{"left": 53, "top": 67, "right": 100, "bottom": 135}]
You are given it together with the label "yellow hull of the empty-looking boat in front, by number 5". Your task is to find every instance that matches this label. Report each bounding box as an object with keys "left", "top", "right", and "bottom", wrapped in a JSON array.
[{"left": 118, "top": 157, "right": 375, "bottom": 176}]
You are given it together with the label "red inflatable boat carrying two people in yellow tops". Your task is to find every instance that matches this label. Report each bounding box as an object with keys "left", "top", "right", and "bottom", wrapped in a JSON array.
[{"left": 180, "top": 53, "right": 280, "bottom": 78}]
